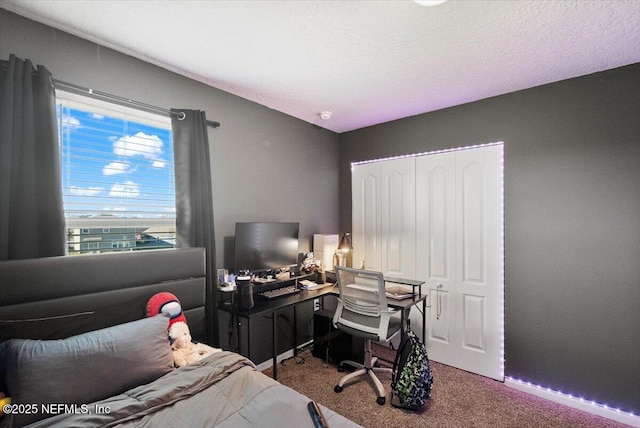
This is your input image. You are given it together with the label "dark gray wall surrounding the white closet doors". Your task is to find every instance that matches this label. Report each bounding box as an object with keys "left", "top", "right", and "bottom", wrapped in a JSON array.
[{"left": 340, "top": 64, "right": 640, "bottom": 414}]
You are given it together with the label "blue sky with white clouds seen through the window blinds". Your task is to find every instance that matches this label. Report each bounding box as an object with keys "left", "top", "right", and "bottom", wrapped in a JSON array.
[{"left": 58, "top": 105, "right": 175, "bottom": 218}]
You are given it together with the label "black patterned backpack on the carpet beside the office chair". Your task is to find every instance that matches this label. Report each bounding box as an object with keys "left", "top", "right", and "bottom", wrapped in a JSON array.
[{"left": 391, "top": 329, "right": 433, "bottom": 410}]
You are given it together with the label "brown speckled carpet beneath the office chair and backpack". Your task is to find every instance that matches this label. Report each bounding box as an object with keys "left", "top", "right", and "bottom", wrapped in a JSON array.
[{"left": 264, "top": 345, "right": 627, "bottom": 428}]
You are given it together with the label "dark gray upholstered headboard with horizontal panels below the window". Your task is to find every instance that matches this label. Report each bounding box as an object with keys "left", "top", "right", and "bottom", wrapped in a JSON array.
[{"left": 0, "top": 248, "right": 207, "bottom": 342}]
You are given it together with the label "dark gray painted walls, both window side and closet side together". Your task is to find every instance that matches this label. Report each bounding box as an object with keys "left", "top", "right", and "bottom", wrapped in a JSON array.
[{"left": 0, "top": 4, "right": 640, "bottom": 413}]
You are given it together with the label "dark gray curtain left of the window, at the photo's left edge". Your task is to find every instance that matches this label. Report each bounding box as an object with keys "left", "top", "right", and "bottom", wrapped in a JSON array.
[{"left": 0, "top": 55, "right": 66, "bottom": 260}]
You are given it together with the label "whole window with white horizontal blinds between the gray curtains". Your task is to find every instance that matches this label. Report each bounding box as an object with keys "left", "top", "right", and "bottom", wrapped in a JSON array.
[{"left": 57, "top": 91, "right": 176, "bottom": 255}]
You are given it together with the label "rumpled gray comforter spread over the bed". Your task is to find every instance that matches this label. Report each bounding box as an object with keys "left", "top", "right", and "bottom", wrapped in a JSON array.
[{"left": 29, "top": 351, "right": 358, "bottom": 428}]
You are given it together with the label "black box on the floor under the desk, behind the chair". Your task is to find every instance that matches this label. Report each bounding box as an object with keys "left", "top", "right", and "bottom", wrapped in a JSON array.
[{"left": 311, "top": 310, "right": 364, "bottom": 365}]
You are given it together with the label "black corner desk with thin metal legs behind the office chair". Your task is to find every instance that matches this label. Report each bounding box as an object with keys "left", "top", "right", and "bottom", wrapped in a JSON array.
[{"left": 218, "top": 281, "right": 426, "bottom": 380}]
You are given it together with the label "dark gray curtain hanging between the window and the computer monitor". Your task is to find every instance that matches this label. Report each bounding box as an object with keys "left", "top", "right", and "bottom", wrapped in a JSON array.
[{"left": 171, "top": 109, "right": 220, "bottom": 346}]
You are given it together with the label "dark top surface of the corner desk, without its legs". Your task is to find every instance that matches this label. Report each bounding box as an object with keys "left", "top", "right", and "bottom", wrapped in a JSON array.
[{"left": 218, "top": 285, "right": 427, "bottom": 318}]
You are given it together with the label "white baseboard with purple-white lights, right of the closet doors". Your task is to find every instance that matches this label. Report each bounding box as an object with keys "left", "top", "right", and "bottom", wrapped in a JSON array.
[{"left": 504, "top": 377, "right": 640, "bottom": 428}]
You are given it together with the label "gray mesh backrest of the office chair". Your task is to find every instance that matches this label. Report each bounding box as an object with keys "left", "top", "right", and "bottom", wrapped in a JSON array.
[{"left": 333, "top": 266, "right": 397, "bottom": 341}]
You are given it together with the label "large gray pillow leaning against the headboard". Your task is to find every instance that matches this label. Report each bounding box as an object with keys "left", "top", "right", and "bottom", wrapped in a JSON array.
[{"left": 0, "top": 315, "right": 174, "bottom": 426}]
